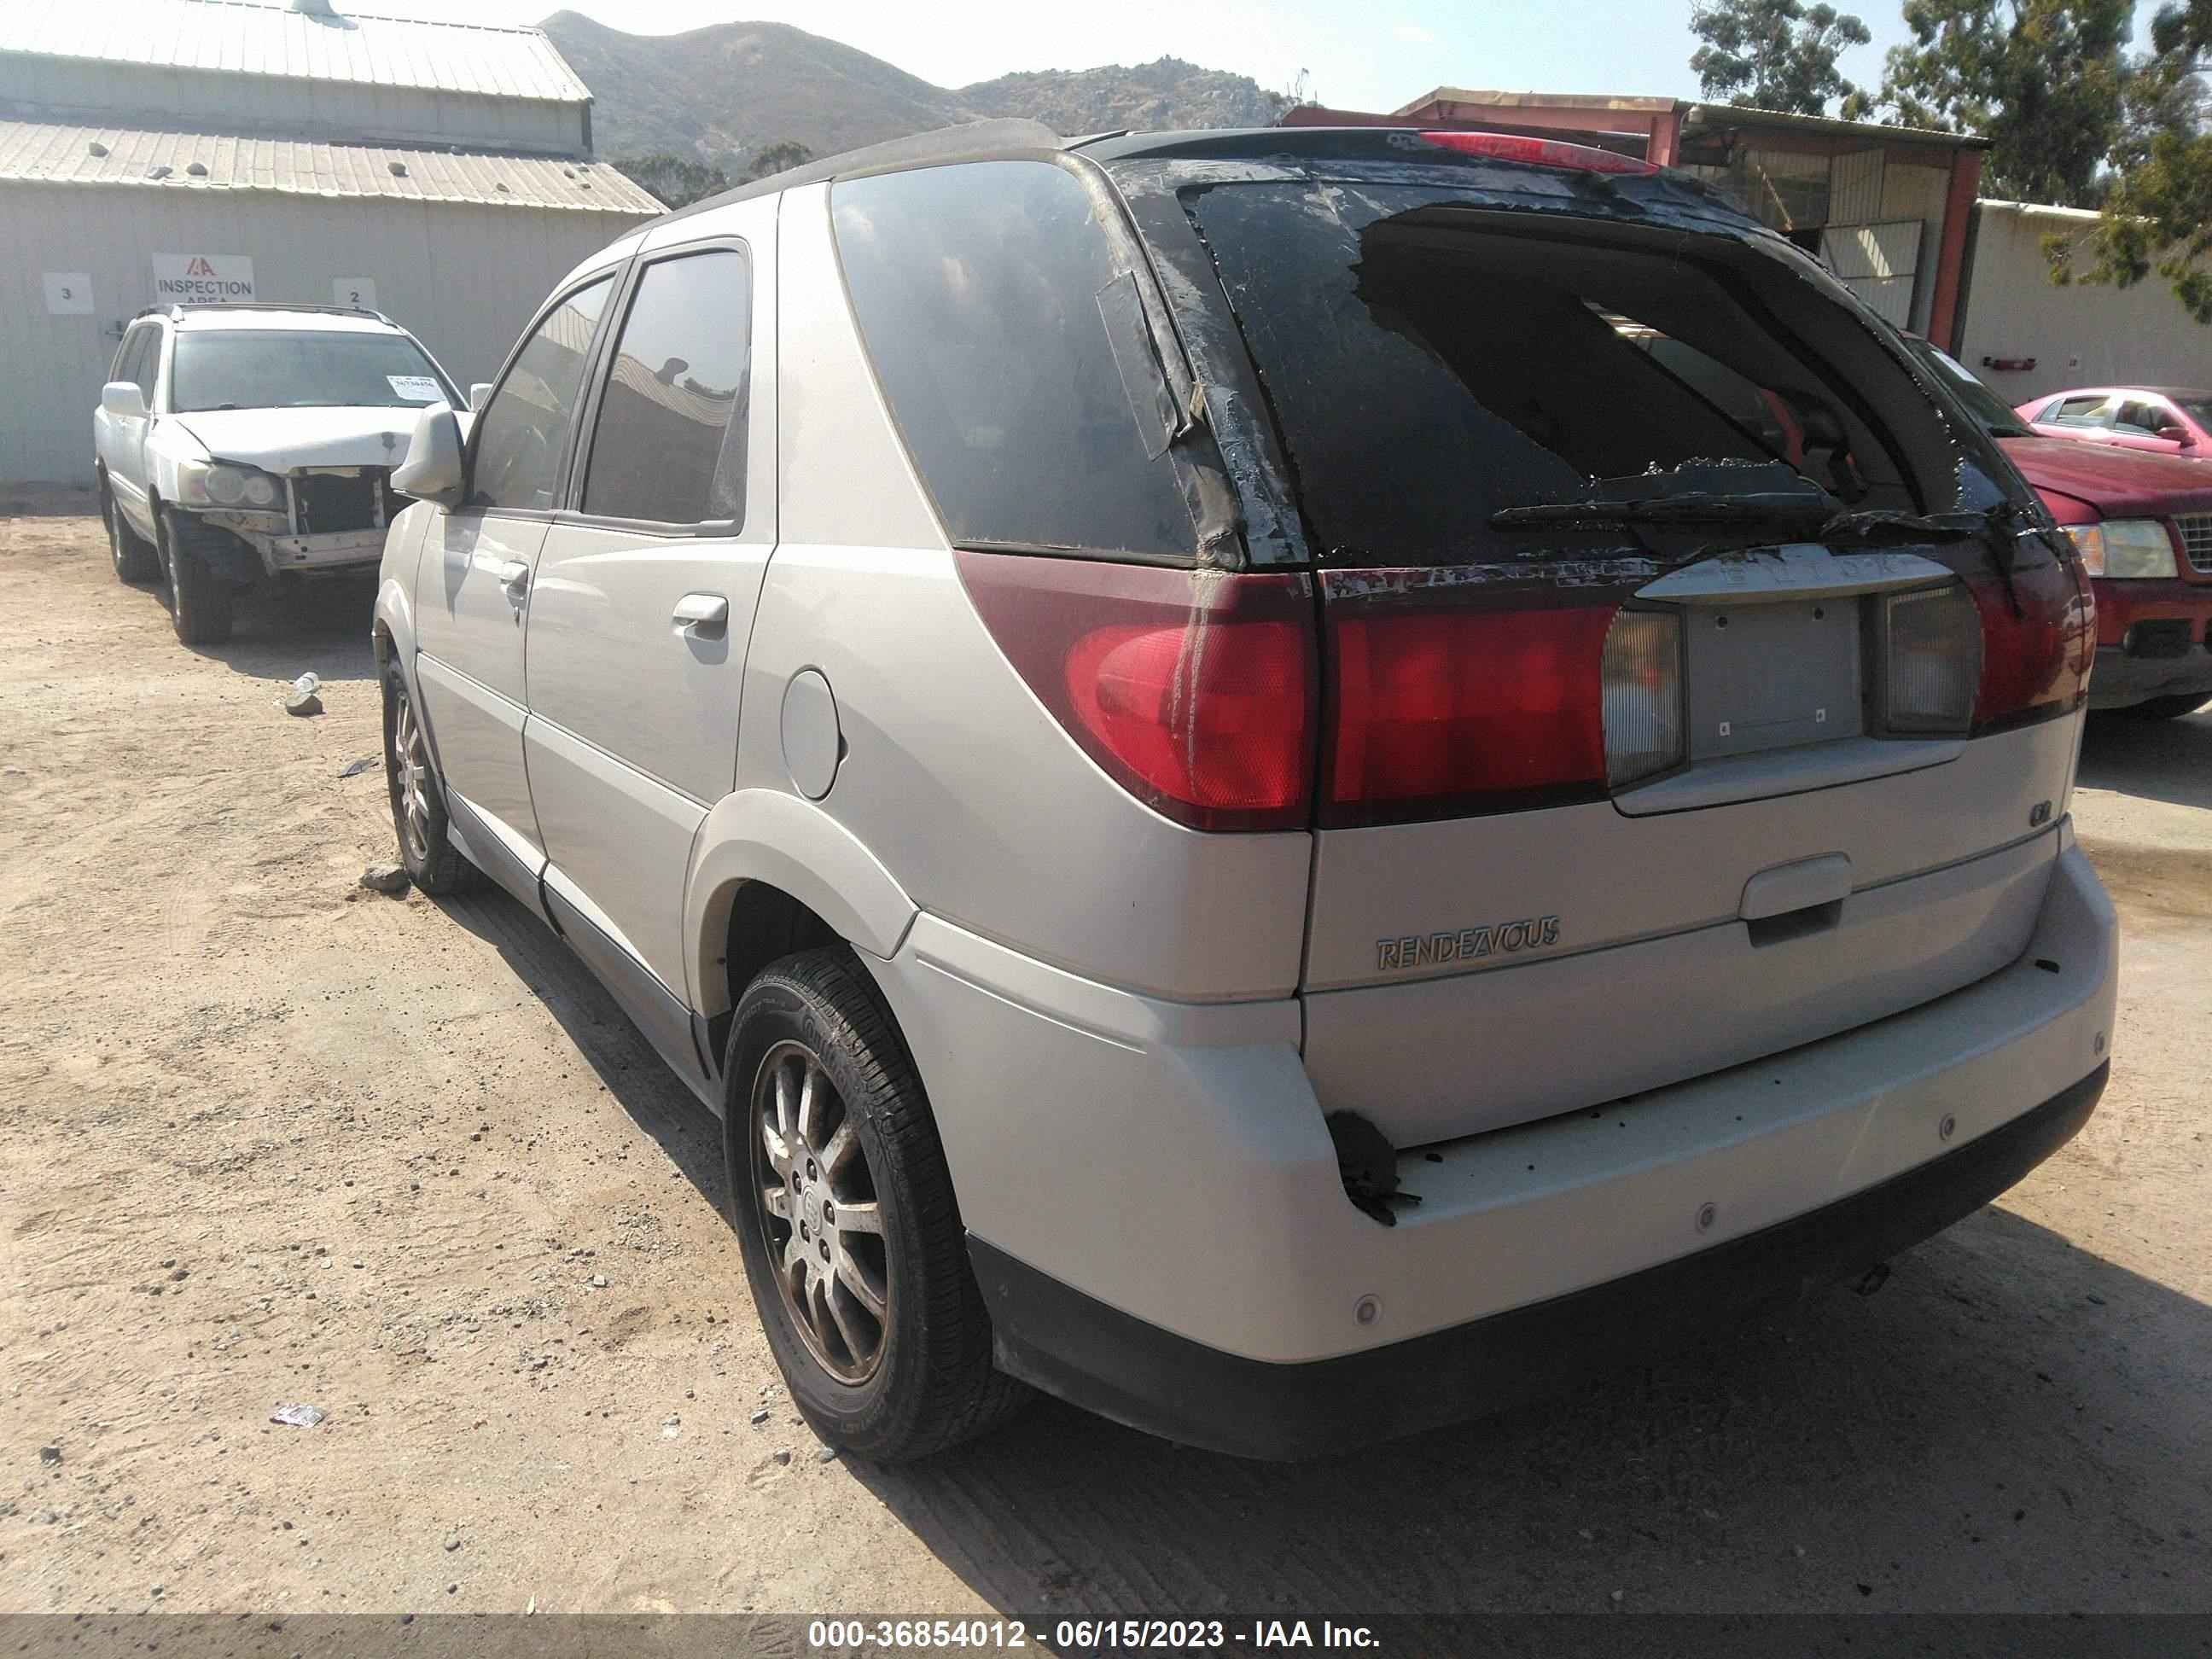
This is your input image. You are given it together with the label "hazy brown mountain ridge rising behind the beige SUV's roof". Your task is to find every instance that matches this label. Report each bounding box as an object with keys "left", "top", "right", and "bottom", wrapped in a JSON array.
[{"left": 539, "top": 11, "right": 1281, "bottom": 177}]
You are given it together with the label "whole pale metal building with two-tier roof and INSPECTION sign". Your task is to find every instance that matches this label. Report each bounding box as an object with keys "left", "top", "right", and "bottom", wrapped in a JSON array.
[{"left": 0, "top": 0, "right": 661, "bottom": 485}]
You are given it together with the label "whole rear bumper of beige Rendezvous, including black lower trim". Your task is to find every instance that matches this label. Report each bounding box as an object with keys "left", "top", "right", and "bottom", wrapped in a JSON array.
[{"left": 871, "top": 825, "right": 2117, "bottom": 1458}]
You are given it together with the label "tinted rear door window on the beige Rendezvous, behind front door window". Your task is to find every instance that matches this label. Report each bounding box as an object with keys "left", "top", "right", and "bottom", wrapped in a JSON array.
[{"left": 584, "top": 250, "right": 752, "bottom": 524}]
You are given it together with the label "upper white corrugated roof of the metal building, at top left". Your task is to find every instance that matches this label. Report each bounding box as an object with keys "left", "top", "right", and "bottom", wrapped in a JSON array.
[{"left": 0, "top": 0, "right": 591, "bottom": 104}]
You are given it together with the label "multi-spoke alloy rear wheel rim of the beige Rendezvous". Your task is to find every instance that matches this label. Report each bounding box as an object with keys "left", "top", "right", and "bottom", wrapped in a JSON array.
[{"left": 750, "top": 1042, "right": 892, "bottom": 1385}]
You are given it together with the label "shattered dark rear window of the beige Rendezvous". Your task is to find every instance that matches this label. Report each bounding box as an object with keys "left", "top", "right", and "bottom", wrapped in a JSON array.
[{"left": 1185, "top": 182, "right": 1958, "bottom": 567}]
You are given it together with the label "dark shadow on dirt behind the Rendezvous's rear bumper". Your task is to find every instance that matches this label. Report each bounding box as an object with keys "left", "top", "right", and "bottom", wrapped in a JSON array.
[{"left": 835, "top": 1208, "right": 2212, "bottom": 1617}]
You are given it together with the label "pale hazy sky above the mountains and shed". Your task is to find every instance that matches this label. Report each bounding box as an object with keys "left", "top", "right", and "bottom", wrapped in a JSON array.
[{"left": 411, "top": 0, "right": 1955, "bottom": 111}]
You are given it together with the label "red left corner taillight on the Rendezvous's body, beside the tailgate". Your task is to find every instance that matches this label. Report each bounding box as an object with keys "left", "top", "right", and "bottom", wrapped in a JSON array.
[{"left": 953, "top": 550, "right": 1314, "bottom": 830}]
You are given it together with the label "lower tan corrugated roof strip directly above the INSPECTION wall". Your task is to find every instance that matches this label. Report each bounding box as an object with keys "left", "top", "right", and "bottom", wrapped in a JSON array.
[{"left": 0, "top": 119, "right": 664, "bottom": 217}]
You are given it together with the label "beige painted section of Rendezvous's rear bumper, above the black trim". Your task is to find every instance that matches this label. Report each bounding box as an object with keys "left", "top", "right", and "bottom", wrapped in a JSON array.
[{"left": 870, "top": 823, "right": 2117, "bottom": 1451}]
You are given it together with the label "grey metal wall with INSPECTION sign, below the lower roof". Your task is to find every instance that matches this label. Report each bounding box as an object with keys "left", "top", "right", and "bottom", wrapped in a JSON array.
[{"left": 0, "top": 183, "right": 646, "bottom": 485}]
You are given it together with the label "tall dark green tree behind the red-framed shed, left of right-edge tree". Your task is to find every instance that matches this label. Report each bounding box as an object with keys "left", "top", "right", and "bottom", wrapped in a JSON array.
[{"left": 1847, "top": 0, "right": 2134, "bottom": 208}]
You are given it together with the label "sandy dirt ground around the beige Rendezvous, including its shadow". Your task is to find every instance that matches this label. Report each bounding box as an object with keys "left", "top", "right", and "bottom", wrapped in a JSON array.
[{"left": 0, "top": 498, "right": 2212, "bottom": 1615}]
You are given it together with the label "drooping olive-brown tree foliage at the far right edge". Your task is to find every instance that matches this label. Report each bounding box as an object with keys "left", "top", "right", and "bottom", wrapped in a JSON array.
[{"left": 2044, "top": 0, "right": 2212, "bottom": 323}]
